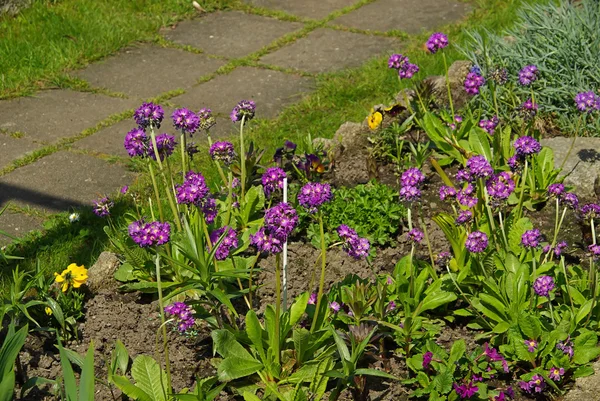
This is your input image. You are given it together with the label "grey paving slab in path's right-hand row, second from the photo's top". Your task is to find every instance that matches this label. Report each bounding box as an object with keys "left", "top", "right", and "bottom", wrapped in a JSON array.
[{"left": 260, "top": 28, "right": 400, "bottom": 73}]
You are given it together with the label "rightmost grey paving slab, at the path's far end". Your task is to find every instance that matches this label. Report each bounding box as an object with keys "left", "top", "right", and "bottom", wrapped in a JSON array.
[{"left": 332, "top": 0, "right": 471, "bottom": 34}]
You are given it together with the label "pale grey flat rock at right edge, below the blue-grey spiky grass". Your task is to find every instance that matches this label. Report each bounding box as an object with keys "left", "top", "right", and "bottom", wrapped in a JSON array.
[{"left": 541, "top": 137, "right": 600, "bottom": 198}]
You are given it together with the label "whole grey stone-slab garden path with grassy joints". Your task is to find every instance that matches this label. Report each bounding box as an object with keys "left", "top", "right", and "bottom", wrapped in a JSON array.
[{"left": 0, "top": 0, "right": 471, "bottom": 241}]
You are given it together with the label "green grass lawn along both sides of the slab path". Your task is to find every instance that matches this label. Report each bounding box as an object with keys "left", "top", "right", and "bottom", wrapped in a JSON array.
[{"left": 0, "top": 0, "right": 544, "bottom": 292}]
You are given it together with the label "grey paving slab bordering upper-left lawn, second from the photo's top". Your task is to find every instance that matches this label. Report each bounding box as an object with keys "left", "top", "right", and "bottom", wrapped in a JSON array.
[{"left": 164, "top": 11, "right": 303, "bottom": 58}]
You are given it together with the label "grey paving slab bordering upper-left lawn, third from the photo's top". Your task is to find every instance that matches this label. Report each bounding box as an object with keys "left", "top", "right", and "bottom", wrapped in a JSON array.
[{"left": 75, "top": 46, "right": 225, "bottom": 99}]
